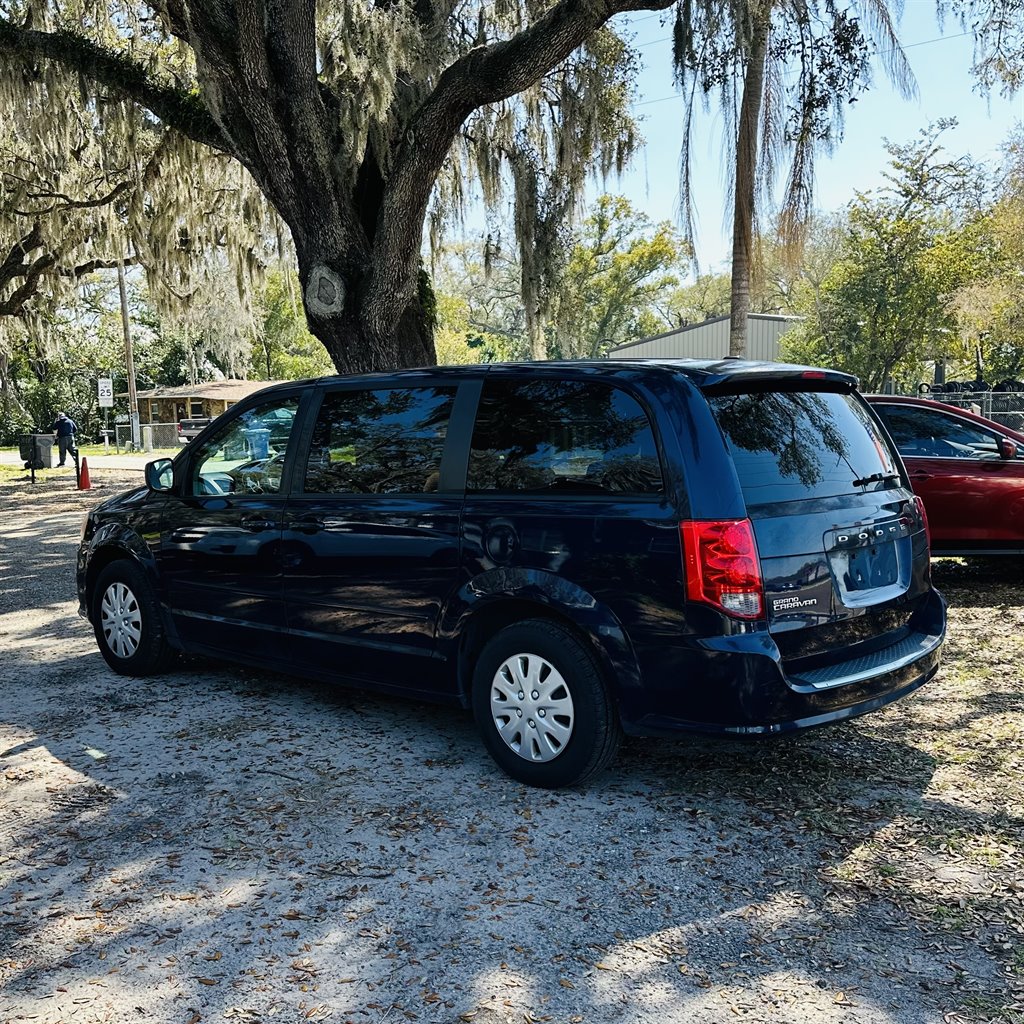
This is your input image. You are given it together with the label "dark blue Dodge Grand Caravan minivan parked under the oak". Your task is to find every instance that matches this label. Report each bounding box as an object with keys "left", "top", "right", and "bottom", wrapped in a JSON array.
[{"left": 78, "top": 359, "right": 945, "bottom": 786}]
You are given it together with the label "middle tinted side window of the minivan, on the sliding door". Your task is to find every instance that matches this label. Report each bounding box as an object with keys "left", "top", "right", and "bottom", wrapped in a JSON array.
[{"left": 304, "top": 387, "right": 455, "bottom": 495}]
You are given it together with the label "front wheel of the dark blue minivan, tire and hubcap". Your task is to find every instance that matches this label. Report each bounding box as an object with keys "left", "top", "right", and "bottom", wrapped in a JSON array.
[{"left": 92, "top": 560, "right": 174, "bottom": 676}]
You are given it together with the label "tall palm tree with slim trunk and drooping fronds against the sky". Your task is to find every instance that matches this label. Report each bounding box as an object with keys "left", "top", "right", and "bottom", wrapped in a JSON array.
[{"left": 674, "top": 0, "right": 916, "bottom": 355}]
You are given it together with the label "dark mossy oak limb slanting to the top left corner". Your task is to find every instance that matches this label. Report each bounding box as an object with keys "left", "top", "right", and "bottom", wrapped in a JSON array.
[{"left": 0, "top": 17, "right": 226, "bottom": 156}]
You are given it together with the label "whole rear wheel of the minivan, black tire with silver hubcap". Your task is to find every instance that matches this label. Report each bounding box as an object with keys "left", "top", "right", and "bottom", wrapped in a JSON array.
[{"left": 472, "top": 618, "right": 622, "bottom": 790}]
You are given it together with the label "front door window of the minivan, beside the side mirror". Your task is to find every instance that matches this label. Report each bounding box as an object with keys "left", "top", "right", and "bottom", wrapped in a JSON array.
[{"left": 189, "top": 398, "right": 299, "bottom": 495}]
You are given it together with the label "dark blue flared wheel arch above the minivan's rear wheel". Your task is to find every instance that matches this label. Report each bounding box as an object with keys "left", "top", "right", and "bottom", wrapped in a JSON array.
[{"left": 438, "top": 568, "right": 641, "bottom": 703}]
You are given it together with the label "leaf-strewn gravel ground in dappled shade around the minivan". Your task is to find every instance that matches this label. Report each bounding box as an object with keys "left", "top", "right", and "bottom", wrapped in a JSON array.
[{"left": 0, "top": 471, "right": 1024, "bottom": 1024}]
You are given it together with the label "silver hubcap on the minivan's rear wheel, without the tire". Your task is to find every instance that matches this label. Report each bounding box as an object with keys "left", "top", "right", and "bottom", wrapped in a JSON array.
[{"left": 490, "top": 654, "right": 574, "bottom": 761}]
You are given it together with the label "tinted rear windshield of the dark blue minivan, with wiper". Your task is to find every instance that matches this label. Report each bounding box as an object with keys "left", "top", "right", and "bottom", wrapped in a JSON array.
[{"left": 708, "top": 390, "right": 900, "bottom": 506}]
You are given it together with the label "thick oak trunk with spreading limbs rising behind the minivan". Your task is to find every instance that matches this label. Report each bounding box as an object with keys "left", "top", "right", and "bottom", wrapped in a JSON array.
[{"left": 0, "top": 0, "right": 673, "bottom": 372}]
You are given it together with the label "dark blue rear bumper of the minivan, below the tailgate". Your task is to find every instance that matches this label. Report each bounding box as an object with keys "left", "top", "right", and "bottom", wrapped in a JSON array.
[{"left": 623, "top": 591, "right": 945, "bottom": 736}]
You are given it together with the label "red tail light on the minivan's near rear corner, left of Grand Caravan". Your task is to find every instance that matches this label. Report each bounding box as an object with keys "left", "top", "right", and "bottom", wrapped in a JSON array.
[{"left": 679, "top": 519, "right": 764, "bottom": 618}]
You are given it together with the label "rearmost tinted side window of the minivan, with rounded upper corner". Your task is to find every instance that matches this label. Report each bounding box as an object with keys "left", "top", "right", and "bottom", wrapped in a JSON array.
[{"left": 467, "top": 380, "right": 662, "bottom": 495}]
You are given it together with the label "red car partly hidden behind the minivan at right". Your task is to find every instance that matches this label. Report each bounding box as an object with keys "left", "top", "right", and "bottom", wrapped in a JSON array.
[{"left": 864, "top": 394, "right": 1024, "bottom": 555}]
